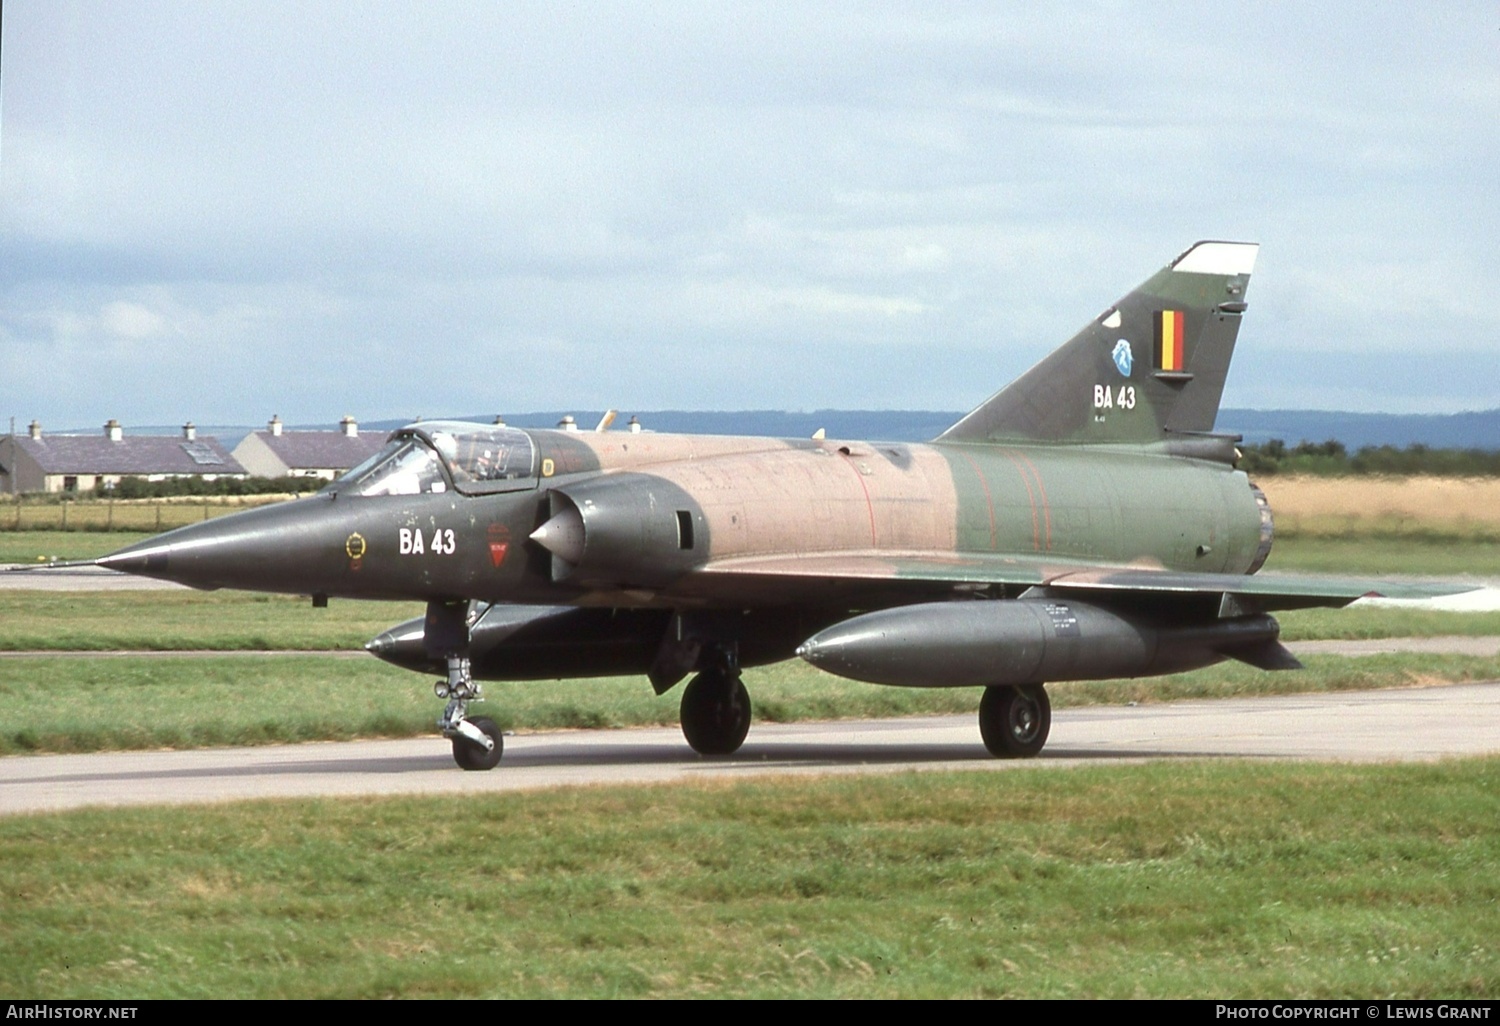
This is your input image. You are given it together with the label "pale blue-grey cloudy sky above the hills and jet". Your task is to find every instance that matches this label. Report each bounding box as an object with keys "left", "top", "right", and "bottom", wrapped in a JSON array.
[{"left": 0, "top": 0, "right": 1500, "bottom": 429}]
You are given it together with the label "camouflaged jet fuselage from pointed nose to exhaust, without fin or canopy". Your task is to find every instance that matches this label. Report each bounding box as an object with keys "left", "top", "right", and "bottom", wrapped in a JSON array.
[{"left": 104, "top": 431, "right": 1263, "bottom": 609}]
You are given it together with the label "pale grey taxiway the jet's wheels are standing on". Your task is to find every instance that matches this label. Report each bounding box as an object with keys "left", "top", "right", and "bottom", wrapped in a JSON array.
[{"left": 0, "top": 683, "right": 1500, "bottom": 815}]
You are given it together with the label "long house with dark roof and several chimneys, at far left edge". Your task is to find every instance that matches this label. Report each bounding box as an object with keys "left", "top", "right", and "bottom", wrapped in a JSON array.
[{"left": 0, "top": 420, "right": 249, "bottom": 494}]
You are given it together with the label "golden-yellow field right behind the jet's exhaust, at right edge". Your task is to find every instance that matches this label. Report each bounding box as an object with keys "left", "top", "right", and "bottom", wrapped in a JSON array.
[{"left": 1256, "top": 477, "right": 1500, "bottom": 539}]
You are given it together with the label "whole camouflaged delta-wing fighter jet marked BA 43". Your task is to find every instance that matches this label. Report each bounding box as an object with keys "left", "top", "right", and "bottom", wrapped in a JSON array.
[{"left": 85, "top": 242, "right": 1454, "bottom": 770}]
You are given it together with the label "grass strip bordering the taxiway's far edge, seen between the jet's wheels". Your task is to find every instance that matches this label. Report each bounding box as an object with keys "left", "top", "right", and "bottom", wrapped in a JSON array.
[{"left": 0, "top": 653, "right": 1500, "bottom": 755}]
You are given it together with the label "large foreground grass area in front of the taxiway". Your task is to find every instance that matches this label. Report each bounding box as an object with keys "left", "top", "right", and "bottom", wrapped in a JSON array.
[{"left": 0, "top": 759, "right": 1500, "bottom": 999}]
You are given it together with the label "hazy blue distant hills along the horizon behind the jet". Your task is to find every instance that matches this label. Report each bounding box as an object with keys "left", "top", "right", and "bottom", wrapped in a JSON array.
[{"left": 57, "top": 410, "right": 1500, "bottom": 452}]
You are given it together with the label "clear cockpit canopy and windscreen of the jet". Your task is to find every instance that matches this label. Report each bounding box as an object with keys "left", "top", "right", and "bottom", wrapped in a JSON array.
[{"left": 327, "top": 420, "right": 537, "bottom": 495}]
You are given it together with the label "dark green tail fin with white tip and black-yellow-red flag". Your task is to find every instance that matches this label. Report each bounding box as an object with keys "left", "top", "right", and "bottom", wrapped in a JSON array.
[{"left": 938, "top": 242, "right": 1260, "bottom": 443}]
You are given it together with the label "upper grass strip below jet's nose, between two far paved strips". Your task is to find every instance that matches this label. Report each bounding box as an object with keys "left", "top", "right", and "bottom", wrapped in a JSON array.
[{"left": 0, "top": 590, "right": 423, "bottom": 651}]
